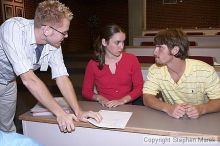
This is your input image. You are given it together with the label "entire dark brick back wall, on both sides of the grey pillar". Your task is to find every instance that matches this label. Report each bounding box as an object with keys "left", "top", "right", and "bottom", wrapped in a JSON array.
[{"left": 6, "top": 0, "right": 220, "bottom": 53}]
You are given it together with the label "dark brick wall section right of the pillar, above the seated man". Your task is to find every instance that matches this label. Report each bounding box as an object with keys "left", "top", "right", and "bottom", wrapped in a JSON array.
[{"left": 147, "top": 0, "right": 220, "bottom": 29}]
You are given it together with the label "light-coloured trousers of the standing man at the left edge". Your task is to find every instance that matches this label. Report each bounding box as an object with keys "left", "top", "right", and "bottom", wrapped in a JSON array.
[{"left": 0, "top": 81, "right": 17, "bottom": 131}]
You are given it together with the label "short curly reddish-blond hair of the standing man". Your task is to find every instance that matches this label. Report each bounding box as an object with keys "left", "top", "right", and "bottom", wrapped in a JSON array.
[{"left": 34, "top": 0, "right": 73, "bottom": 27}]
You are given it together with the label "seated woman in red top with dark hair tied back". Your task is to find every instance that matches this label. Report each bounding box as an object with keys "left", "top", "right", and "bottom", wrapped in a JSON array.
[{"left": 82, "top": 24, "right": 143, "bottom": 108}]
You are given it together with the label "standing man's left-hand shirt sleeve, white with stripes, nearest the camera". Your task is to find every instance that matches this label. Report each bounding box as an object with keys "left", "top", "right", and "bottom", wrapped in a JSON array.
[{"left": 1, "top": 18, "right": 32, "bottom": 76}]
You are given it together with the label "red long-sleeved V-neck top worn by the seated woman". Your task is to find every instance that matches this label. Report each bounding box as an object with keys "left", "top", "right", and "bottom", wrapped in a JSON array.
[{"left": 82, "top": 52, "right": 143, "bottom": 100}]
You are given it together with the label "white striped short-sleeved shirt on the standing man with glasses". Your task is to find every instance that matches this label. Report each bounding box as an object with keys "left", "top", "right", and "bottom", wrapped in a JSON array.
[{"left": 0, "top": 17, "right": 68, "bottom": 84}]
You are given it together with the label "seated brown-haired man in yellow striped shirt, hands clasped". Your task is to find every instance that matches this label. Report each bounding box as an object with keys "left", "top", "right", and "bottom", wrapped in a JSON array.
[{"left": 143, "top": 29, "right": 220, "bottom": 119}]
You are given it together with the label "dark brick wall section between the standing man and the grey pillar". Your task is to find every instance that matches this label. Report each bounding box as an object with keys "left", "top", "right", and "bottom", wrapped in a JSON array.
[{"left": 63, "top": 0, "right": 128, "bottom": 53}]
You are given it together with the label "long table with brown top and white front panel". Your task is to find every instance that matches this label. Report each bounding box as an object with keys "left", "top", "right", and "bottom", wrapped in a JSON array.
[{"left": 20, "top": 101, "right": 220, "bottom": 146}]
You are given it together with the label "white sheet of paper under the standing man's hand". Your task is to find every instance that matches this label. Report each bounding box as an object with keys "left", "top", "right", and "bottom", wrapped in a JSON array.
[{"left": 88, "top": 110, "right": 132, "bottom": 129}]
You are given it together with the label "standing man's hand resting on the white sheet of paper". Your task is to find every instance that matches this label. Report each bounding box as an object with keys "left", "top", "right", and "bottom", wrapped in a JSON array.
[{"left": 77, "top": 111, "right": 102, "bottom": 123}]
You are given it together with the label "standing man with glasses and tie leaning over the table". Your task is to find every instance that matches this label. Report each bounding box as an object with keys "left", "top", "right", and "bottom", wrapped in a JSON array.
[{"left": 0, "top": 0, "right": 101, "bottom": 132}]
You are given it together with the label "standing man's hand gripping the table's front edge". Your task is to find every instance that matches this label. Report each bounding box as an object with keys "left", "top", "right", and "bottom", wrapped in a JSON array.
[{"left": 57, "top": 113, "right": 79, "bottom": 133}]
